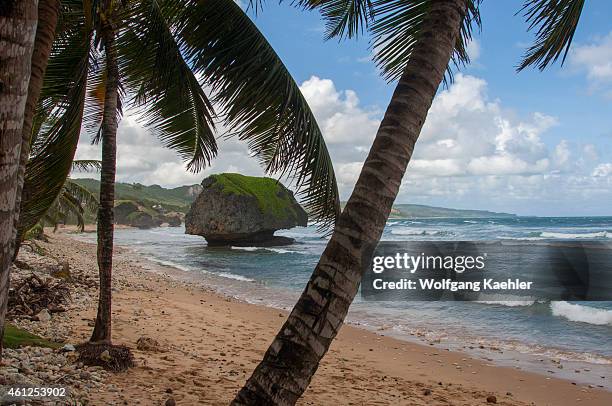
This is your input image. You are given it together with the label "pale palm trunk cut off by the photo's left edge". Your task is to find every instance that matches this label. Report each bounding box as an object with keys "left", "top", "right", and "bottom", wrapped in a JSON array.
[{"left": 0, "top": 0, "right": 37, "bottom": 358}]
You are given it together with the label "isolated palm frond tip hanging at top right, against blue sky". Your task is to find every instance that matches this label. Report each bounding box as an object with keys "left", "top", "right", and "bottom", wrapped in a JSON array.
[{"left": 517, "top": 0, "right": 584, "bottom": 71}]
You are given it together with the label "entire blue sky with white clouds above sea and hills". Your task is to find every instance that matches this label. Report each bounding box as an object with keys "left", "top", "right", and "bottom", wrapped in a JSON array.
[{"left": 74, "top": 0, "right": 612, "bottom": 216}]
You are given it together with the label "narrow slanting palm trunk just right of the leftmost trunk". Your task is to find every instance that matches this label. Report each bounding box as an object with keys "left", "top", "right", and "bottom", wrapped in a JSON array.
[{"left": 13, "top": 0, "right": 60, "bottom": 260}]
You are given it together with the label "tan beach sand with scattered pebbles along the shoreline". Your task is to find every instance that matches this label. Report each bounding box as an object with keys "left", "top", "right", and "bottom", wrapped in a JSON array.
[{"left": 15, "top": 230, "right": 612, "bottom": 406}]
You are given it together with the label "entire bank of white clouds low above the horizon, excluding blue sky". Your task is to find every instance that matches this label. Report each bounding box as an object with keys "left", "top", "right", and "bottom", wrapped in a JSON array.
[{"left": 77, "top": 74, "right": 612, "bottom": 215}]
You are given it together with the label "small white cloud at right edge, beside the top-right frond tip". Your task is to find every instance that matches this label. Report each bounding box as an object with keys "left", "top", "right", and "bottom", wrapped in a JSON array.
[{"left": 569, "top": 31, "right": 612, "bottom": 92}]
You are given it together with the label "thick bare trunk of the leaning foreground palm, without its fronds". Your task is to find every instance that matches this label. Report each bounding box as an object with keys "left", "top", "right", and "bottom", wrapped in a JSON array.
[{"left": 232, "top": 0, "right": 467, "bottom": 405}]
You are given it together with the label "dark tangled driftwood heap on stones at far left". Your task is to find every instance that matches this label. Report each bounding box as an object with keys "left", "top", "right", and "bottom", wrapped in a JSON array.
[{"left": 8, "top": 273, "right": 70, "bottom": 318}]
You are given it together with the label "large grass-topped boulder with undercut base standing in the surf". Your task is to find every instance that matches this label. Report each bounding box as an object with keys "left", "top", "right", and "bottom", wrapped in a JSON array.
[{"left": 185, "top": 173, "right": 308, "bottom": 246}]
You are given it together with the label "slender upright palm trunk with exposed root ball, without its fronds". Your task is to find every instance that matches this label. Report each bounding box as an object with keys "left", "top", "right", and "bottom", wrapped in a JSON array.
[{"left": 90, "top": 24, "right": 119, "bottom": 344}]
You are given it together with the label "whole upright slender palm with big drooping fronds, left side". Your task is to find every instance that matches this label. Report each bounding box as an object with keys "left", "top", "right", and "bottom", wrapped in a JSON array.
[{"left": 10, "top": 0, "right": 339, "bottom": 366}]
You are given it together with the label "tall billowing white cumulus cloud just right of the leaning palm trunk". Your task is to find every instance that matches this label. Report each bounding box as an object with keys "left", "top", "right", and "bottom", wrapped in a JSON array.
[{"left": 409, "top": 74, "right": 563, "bottom": 176}]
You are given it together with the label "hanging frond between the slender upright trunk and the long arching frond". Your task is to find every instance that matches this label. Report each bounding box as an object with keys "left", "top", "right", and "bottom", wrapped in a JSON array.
[{"left": 118, "top": 0, "right": 217, "bottom": 171}]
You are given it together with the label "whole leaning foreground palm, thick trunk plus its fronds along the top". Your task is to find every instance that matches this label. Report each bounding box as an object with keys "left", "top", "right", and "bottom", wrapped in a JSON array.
[{"left": 232, "top": 0, "right": 584, "bottom": 405}]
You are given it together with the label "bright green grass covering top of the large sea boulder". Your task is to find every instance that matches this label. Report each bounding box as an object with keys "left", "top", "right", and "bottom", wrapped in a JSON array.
[{"left": 212, "top": 173, "right": 295, "bottom": 218}]
